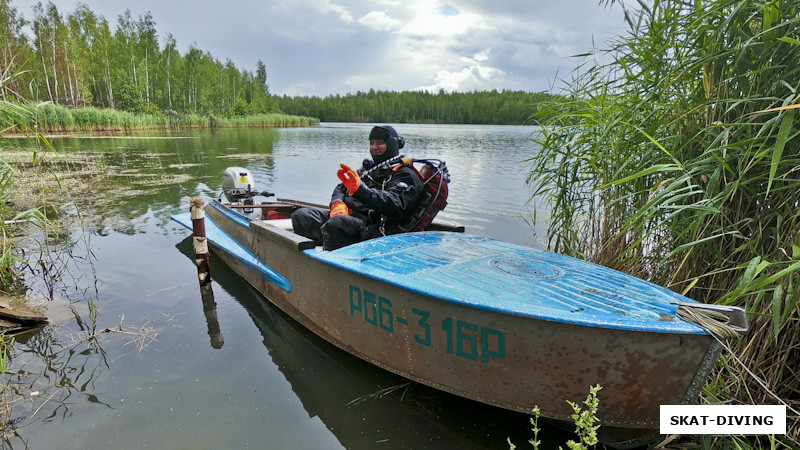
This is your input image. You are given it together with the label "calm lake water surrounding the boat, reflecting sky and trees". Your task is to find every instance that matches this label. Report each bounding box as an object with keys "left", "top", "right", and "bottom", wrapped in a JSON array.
[{"left": 6, "top": 124, "right": 580, "bottom": 449}]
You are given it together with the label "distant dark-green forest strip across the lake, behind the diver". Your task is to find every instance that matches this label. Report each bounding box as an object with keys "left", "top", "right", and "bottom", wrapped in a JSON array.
[{"left": 276, "top": 90, "right": 553, "bottom": 125}]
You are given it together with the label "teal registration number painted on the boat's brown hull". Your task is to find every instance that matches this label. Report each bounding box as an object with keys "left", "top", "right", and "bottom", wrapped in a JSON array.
[{"left": 349, "top": 284, "right": 506, "bottom": 364}]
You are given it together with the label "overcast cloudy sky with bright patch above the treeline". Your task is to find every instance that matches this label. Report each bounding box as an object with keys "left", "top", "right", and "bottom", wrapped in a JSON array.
[{"left": 11, "top": 0, "right": 625, "bottom": 96}]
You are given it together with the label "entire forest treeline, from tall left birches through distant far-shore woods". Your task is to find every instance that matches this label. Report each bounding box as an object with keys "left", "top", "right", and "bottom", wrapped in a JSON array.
[{"left": 0, "top": 0, "right": 551, "bottom": 125}]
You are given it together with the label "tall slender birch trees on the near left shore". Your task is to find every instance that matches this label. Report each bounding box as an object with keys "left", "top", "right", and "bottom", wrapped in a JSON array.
[{"left": 0, "top": 0, "right": 279, "bottom": 115}]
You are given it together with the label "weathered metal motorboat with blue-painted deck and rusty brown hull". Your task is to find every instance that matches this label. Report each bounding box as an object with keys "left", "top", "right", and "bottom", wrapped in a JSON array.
[{"left": 173, "top": 200, "right": 746, "bottom": 448}]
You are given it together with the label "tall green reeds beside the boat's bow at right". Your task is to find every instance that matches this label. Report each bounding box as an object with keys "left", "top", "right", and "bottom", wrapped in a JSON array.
[{"left": 531, "top": 0, "right": 800, "bottom": 444}]
